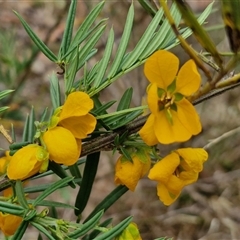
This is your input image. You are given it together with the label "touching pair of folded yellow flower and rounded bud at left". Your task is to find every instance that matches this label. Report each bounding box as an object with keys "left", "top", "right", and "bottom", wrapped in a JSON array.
[{"left": 7, "top": 92, "right": 96, "bottom": 180}]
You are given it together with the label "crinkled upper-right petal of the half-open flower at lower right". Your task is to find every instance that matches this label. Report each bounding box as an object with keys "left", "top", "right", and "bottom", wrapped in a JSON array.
[{"left": 176, "top": 148, "right": 208, "bottom": 172}]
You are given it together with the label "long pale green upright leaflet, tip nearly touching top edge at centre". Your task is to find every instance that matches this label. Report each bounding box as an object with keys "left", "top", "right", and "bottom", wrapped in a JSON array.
[{"left": 107, "top": 4, "right": 134, "bottom": 78}]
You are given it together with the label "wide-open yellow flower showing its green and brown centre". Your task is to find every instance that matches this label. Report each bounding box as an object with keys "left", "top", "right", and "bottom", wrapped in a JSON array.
[{"left": 139, "top": 50, "right": 202, "bottom": 146}]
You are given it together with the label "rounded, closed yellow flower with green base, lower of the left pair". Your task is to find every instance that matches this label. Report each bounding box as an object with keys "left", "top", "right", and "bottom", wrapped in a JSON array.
[{"left": 7, "top": 144, "right": 48, "bottom": 180}]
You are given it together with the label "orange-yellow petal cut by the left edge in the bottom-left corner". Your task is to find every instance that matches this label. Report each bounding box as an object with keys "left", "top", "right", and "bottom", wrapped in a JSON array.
[{"left": 0, "top": 212, "right": 22, "bottom": 236}]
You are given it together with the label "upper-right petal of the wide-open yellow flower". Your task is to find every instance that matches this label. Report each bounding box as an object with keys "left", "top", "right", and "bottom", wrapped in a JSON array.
[{"left": 175, "top": 60, "right": 201, "bottom": 96}]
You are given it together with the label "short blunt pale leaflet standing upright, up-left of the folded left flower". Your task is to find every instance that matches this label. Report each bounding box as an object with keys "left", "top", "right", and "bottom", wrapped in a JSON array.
[{"left": 50, "top": 72, "right": 61, "bottom": 109}]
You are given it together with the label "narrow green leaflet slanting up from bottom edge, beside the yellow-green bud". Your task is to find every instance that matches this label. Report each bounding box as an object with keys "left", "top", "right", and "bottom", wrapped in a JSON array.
[{"left": 94, "top": 217, "right": 132, "bottom": 240}]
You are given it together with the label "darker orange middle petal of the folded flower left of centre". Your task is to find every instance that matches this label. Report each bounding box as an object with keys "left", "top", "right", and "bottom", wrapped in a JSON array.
[{"left": 59, "top": 114, "right": 97, "bottom": 139}]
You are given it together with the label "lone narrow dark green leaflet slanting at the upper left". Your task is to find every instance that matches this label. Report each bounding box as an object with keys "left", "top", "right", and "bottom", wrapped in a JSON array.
[{"left": 13, "top": 11, "right": 58, "bottom": 62}]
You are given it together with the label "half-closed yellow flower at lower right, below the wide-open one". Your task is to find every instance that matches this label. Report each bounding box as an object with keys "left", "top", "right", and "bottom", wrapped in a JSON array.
[{"left": 148, "top": 148, "right": 208, "bottom": 206}]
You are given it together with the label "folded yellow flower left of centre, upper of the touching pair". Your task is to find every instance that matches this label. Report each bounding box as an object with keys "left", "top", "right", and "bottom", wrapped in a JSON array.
[{"left": 43, "top": 92, "right": 96, "bottom": 166}]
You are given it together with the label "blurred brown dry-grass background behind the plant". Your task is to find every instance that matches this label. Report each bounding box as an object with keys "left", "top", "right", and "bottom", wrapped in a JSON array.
[{"left": 0, "top": 0, "right": 240, "bottom": 240}]
